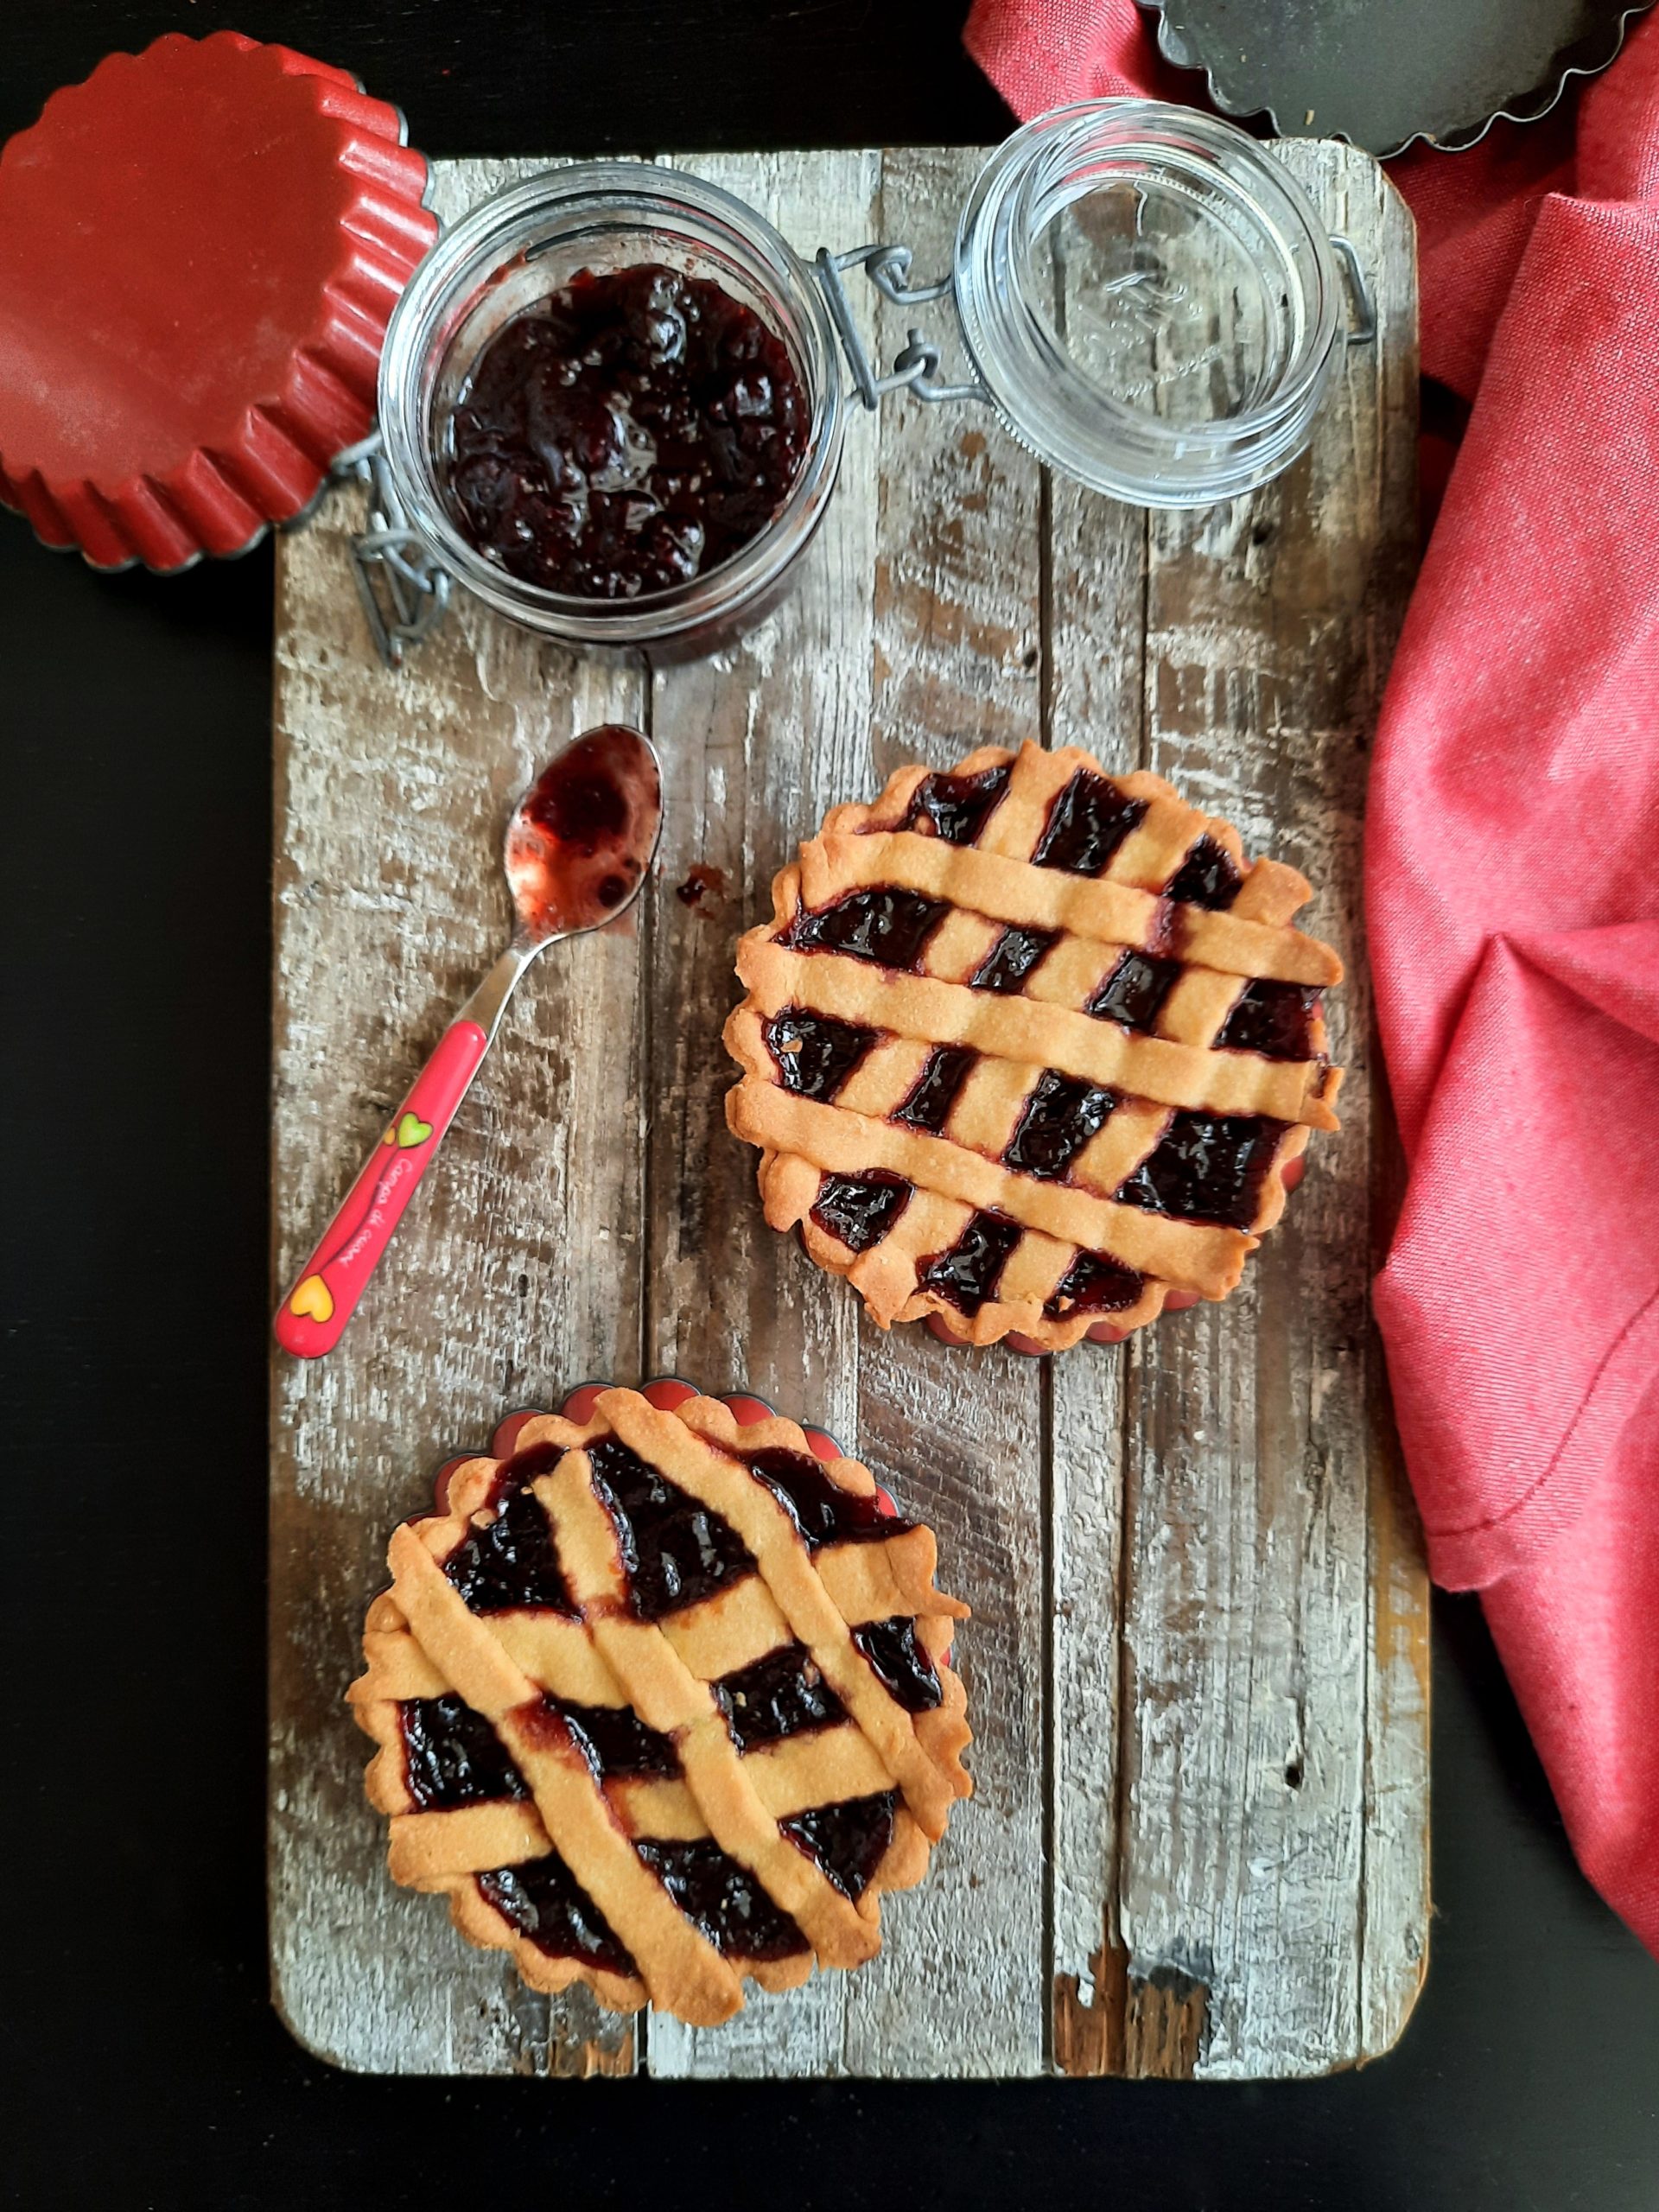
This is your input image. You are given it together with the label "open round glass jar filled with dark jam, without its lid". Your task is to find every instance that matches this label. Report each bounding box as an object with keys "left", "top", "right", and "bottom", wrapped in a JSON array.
[{"left": 380, "top": 162, "right": 847, "bottom": 652}]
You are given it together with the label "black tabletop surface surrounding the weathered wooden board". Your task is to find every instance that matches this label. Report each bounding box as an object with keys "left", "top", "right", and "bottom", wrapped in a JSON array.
[{"left": 0, "top": 0, "right": 1659, "bottom": 2212}]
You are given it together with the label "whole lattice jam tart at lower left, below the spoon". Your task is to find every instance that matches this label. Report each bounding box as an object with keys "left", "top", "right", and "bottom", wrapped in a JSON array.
[{"left": 349, "top": 1387, "right": 971, "bottom": 2024}]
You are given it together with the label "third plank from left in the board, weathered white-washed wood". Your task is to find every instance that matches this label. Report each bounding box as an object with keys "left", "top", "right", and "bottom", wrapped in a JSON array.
[{"left": 847, "top": 149, "right": 1048, "bottom": 2075}]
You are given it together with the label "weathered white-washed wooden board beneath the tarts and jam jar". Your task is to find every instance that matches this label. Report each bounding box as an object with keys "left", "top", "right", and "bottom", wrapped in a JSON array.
[{"left": 270, "top": 142, "right": 1429, "bottom": 2079}]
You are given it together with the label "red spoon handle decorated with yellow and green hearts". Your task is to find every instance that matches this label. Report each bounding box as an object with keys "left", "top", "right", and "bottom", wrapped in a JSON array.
[{"left": 276, "top": 1015, "right": 489, "bottom": 1360}]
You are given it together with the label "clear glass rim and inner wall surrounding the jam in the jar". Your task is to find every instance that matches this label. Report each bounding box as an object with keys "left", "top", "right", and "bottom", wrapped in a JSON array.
[{"left": 378, "top": 162, "right": 845, "bottom": 644}]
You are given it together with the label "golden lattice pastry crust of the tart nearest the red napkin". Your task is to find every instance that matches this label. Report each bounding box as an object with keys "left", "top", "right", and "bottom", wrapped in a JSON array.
[{"left": 726, "top": 743, "right": 1343, "bottom": 1351}]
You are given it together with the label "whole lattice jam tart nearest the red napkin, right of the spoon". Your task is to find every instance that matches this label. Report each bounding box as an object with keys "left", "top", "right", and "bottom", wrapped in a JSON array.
[{"left": 726, "top": 746, "right": 1343, "bottom": 1351}]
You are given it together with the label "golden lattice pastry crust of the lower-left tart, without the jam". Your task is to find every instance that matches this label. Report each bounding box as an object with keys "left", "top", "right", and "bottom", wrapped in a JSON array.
[{"left": 347, "top": 1389, "right": 971, "bottom": 2026}]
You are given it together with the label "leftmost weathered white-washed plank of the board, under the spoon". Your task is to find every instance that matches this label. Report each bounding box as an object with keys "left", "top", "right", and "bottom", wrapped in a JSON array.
[{"left": 270, "top": 162, "right": 641, "bottom": 2073}]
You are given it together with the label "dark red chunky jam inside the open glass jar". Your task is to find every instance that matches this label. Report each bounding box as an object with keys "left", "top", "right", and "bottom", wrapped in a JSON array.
[{"left": 449, "top": 264, "right": 812, "bottom": 600}]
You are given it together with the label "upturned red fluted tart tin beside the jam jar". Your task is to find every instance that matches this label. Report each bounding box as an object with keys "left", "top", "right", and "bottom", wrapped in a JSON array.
[{"left": 0, "top": 31, "right": 438, "bottom": 570}]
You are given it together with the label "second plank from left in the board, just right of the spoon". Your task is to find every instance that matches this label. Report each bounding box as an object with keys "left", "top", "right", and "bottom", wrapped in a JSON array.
[{"left": 646, "top": 153, "right": 889, "bottom": 2077}]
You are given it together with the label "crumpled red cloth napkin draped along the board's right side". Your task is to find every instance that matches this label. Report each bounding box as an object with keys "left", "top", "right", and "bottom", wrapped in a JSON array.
[{"left": 967, "top": 0, "right": 1659, "bottom": 1953}]
